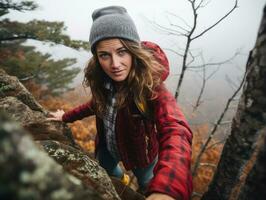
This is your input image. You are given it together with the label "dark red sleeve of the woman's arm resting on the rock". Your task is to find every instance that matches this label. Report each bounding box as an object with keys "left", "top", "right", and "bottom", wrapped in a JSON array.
[{"left": 62, "top": 101, "right": 94, "bottom": 122}]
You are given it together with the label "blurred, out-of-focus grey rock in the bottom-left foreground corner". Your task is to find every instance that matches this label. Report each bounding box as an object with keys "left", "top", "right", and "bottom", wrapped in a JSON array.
[{"left": 0, "top": 113, "right": 102, "bottom": 200}]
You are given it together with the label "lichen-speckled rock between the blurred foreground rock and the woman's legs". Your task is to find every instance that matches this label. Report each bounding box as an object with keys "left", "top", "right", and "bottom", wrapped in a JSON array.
[{"left": 41, "top": 140, "right": 120, "bottom": 199}]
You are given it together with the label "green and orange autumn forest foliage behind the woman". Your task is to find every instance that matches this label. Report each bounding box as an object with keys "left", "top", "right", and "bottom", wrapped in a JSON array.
[{"left": 0, "top": 0, "right": 264, "bottom": 199}]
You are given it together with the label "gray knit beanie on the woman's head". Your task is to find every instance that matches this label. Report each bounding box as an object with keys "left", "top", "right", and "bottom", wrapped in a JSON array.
[{"left": 90, "top": 6, "right": 140, "bottom": 53}]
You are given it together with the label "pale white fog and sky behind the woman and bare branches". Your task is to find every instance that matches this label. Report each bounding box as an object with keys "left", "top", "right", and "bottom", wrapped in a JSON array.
[{"left": 5, "top": 0, "right": 266, "bottom": 123}]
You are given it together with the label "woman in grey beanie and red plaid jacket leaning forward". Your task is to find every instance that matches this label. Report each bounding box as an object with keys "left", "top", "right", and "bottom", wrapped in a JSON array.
[{"left": 48, "top": 6, "right": 192, "bottom": 200}]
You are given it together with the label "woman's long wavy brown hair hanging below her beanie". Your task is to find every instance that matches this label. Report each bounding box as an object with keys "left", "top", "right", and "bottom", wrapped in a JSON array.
[{"left": 83, "top": 39, "right": 164, "bottom": 117}]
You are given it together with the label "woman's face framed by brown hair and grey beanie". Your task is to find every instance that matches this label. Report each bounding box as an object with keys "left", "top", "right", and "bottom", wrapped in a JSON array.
[{"left": 96, "top": 39, "right": 132, "bottom": 82}]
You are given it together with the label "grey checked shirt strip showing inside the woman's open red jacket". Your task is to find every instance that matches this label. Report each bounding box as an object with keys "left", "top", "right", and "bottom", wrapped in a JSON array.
[{"left": 103, "top": 83, "right": 120, "bottom": 160}]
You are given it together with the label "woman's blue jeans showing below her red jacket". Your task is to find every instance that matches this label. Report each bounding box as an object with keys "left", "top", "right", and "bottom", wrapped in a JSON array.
[{"left": 96, "top": 147, "right": 158, "bottom": 191}]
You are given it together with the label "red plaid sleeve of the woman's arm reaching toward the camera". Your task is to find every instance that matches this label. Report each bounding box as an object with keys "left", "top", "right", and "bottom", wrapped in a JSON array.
[{"left": 148, "top": 85, "right": 192, "bottom": 200}]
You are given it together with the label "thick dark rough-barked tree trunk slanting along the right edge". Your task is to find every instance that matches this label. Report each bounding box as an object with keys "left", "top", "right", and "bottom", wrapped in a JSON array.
[{"left": 202, "top": 4, "right": 266, "bottom": 200}]
